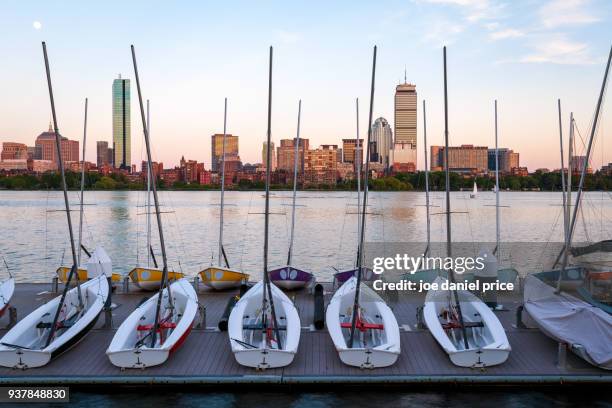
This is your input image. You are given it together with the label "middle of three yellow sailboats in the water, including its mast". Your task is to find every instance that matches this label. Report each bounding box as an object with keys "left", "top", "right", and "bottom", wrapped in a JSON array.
[{"left": 128, "top": 99, "right": 185, "bottom": 291}]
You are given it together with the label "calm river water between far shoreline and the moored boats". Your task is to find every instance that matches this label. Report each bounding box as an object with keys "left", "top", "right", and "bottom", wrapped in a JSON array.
[{"left": 0, "top": 191, "right": 612, "bottom": 282}]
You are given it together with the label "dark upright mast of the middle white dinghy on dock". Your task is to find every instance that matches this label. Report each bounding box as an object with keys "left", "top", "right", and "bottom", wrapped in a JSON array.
[{"left": 262, "top": 46, "right": 283, "bottom": 349}]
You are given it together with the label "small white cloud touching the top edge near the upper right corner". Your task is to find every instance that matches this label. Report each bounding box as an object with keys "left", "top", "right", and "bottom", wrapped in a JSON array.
[{"left": 539, "top": 0, "right": 599, "bottom": 28}]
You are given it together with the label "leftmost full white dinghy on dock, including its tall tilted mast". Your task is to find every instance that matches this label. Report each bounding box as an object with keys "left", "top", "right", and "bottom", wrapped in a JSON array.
[{"left": 0, "top": 42, "right": 109, "bottom": 369}]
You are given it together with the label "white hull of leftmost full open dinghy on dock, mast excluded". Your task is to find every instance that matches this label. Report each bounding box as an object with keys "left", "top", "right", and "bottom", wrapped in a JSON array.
[{"left": 0, "top": 276, "right": 109, "bottom": 369}]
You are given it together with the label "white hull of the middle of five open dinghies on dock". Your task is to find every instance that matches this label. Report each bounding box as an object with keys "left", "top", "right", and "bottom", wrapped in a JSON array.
[{"left": 228, "top": 282, "right": 301, "bottom": 370}]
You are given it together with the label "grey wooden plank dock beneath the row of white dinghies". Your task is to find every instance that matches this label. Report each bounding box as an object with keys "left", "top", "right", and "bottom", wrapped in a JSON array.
[{"left": 0, "top": 283, "right": 612, "bottom": 385}]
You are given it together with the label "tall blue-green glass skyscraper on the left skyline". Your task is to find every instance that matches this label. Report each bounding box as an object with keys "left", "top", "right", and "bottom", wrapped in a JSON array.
[{"left": 113, "top": 75, "right": 132, "bottom": 170}]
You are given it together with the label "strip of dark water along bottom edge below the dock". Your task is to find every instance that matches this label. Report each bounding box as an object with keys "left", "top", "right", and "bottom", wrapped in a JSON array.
[{"left": 37, "top": 386, "right": 612, "bottom": 408}]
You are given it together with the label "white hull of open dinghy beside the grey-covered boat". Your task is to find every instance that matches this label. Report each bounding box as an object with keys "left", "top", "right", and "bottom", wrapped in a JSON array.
[{"left": 423, "top": 278, "right": 512, "bottom": 367}]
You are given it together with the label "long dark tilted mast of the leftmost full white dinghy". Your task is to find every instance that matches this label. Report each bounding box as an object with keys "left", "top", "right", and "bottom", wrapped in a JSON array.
[{"left": 42, "top": 41, "right": 84, "bottom": 347}]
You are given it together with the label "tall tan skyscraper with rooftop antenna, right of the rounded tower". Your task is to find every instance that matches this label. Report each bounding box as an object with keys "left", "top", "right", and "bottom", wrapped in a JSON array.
[{"left": 392, "top": 77, "right": 417, "bottom": 169}]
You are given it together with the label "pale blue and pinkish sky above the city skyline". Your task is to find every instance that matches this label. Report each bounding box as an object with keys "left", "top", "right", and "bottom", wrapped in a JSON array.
[{"left": 0, "top": 0, "right": 612, "bottom": 170}]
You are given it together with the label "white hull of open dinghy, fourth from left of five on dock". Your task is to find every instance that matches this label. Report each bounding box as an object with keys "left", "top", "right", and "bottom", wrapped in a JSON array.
[{"left": 325, "top": 277, "right": 400, "bottom": 368}]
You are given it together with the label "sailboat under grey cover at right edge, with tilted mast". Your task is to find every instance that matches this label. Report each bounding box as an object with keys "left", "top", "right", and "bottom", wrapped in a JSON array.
[{"left": 523, "top": 47, "right": 612, "bottom": 370}]
